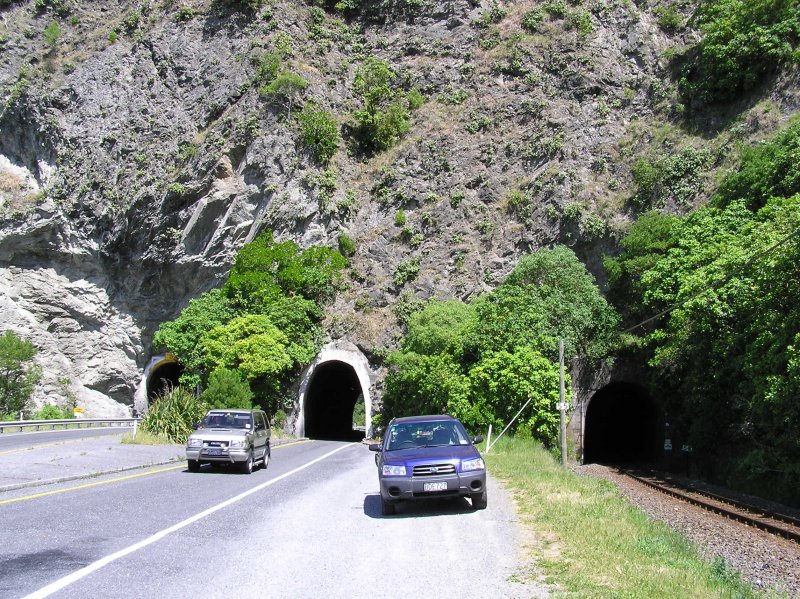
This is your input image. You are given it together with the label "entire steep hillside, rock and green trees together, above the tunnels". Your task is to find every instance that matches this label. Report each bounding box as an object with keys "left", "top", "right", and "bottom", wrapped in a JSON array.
[{"left": 0, "top": 0, "right": 800, "bottom": 506}]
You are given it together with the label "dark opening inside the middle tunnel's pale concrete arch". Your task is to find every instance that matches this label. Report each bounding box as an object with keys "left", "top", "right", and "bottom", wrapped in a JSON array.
[{"left": 305, "top": 361, "right": 364, "bottom": 441}]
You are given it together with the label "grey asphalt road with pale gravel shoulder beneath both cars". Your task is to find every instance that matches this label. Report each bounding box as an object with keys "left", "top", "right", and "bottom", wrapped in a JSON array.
[{"left": 0, "top": 441, "right": 545, "bottom": 598}]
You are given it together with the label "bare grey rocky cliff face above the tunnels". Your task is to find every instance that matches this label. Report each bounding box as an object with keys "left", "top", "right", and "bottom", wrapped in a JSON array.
[{"left": 0, "top": 0, "right": 789, "bottom": 415}]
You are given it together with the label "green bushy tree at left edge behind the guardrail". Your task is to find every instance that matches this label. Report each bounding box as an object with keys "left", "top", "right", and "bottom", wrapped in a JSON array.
[{"left": 0, "top": 330, "right": 42, "bottom": 417}]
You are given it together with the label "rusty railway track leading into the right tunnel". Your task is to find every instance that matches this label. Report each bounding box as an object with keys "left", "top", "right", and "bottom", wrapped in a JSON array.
[{"left": 619, "top": 469, "right": 800, "bottom": 544}]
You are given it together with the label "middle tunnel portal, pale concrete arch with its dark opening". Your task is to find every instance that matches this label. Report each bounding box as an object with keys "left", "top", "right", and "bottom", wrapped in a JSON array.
[{"left": 295, "top": 343, "right": 372, "bottom": 440}]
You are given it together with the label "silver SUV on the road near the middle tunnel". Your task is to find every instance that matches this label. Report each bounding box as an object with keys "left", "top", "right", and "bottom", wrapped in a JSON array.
[{"left": 186, "top": 410, "right": 270, "bottom": 474}]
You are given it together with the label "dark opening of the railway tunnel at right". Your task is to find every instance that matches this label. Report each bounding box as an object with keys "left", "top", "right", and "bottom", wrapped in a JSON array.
[{"left": 583, "top": 383, "right": 659, "bottom": 465}]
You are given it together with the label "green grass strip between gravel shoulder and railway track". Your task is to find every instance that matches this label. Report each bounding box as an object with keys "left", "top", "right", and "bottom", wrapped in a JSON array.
[{"left": 486, "top": 439, "right": 758, "bottom": 599}]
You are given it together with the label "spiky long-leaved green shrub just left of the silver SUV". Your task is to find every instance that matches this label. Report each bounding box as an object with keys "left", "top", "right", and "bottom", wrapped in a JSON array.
[{"left": 141, "top": 387, "right": 208, "bottom": 443}]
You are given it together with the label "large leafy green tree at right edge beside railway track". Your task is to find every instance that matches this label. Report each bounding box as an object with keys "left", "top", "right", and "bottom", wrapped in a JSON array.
[{"left": 624, "top": 195, "right": 800, "bottom": 504}]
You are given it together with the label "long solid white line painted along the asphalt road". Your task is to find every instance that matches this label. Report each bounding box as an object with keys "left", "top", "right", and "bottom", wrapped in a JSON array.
[{"left": 24, "top": 443, "right": 353, "bottom": 599}]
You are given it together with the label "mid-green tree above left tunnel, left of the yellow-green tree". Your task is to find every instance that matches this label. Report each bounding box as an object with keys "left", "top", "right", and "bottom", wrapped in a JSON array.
[{"left": 153, "top": 289, "right": 234, "bottom": 387}]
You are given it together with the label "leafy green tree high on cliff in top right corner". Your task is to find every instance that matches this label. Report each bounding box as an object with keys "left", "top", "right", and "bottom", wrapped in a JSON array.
[{"left": 679, "top": 0, "right": 800, "bottom": 105}]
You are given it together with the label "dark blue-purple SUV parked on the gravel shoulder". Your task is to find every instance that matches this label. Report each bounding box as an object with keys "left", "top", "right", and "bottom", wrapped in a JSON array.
[{"left": 369, "top": 415, "right": 487, "bottom": 516}]
